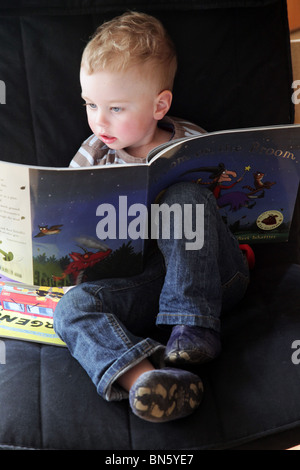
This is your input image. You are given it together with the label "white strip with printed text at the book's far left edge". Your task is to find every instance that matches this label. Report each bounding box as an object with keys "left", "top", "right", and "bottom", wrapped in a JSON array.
[{"left": 0, "top": 162, "right": 32, "bottom": 283}]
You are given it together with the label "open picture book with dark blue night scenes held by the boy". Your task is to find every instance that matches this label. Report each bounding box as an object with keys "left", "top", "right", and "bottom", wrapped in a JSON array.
[{"left": 0, "top": 125, "right": 300, "bottom": 346}]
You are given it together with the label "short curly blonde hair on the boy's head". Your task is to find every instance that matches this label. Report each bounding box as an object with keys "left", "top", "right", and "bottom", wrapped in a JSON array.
[{"left": 81, "top": 12, "right": 177, "bottom": 91}]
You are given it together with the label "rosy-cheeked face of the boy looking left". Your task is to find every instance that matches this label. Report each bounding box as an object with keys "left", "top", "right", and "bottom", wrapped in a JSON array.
[{"left": 80, "top": 67, "right": 170, "bottom": 156}]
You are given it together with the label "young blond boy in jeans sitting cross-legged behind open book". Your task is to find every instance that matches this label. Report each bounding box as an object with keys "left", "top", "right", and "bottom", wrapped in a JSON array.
[{"left": 54, "top": 12, "right": 248, "bottom": 422}]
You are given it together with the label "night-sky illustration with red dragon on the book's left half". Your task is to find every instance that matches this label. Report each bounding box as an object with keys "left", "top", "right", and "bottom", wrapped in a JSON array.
[{"left": 27, "top": 165, "right": 147, "bottom": 287}]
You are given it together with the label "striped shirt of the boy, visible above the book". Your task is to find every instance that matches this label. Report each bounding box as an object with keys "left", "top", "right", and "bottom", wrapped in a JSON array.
[{"left": 70, "top": 116, "right": 205, "bottom": 168}]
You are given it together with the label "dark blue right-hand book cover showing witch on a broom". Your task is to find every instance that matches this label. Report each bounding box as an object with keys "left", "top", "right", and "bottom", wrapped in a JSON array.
[{"left": 148, "top": 125, "right": 300, "bottom": 242}]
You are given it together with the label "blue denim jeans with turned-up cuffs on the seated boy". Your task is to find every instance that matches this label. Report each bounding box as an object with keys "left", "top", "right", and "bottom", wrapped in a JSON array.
[{"left": 54, "top": 183, "right": 249, "bottom": 401}]
